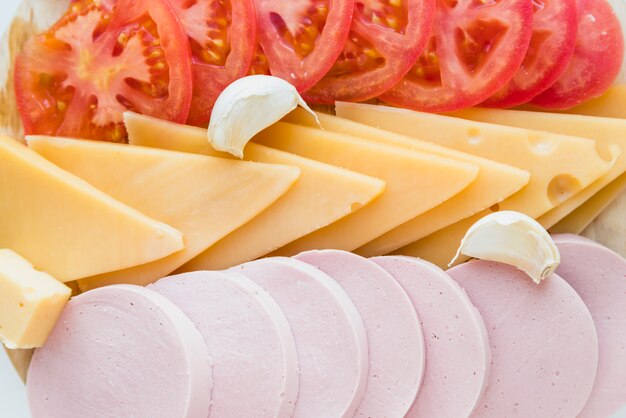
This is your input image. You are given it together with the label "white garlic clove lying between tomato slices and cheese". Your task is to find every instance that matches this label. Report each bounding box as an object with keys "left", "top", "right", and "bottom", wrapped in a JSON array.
[{"left": 208, "top": 75, "right": 319, "bottom": 158}]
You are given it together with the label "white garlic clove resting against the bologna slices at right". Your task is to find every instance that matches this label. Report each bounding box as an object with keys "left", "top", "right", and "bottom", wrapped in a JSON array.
[{"left": 450, "top": 211, "right": 561, "bottom": 284}]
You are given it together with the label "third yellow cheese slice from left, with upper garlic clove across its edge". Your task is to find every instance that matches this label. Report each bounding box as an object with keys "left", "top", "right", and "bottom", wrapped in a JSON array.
[{"left": 125, "top": 113, "right": 385, "bottom": 271}]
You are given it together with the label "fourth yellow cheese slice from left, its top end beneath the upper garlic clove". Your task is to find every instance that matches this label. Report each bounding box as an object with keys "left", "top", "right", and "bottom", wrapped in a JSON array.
[{"left": 254, "top": 122, "right": 478, "bottom": 251}]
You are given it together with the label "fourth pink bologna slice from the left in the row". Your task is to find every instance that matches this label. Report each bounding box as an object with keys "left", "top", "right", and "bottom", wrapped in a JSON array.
[{"left": 295, "top": 250, "right": 425, "bottom": 417}]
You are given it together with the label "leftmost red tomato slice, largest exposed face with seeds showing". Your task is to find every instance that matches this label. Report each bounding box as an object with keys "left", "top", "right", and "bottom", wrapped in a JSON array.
[{"left": 15, "top": 0, "right": 192, "bottom": 141}]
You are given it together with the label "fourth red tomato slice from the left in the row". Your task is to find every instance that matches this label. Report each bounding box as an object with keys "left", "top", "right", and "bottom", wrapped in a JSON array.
[{"left": 305, "top": 0, "right": 435, "bottom": 103}]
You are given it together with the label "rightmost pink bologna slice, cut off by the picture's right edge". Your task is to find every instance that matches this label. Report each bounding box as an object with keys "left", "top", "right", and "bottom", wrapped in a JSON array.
[{"left": 553, "top": 234, "right": 626, "bottom": 418}]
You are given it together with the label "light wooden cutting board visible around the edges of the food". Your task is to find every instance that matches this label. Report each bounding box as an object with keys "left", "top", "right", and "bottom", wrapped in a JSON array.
[{"left": 0, "top": 0, "right": 626, "bottom": 379}]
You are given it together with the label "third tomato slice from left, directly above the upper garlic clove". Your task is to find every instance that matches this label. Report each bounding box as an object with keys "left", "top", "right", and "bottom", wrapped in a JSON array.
[{"left": 252, "top": 0, "right": 354, "bottom": 91}]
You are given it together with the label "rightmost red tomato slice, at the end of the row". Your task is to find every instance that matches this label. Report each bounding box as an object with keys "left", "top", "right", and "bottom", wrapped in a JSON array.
[{"left": 532, "top": 0, "right": 624, "bottom": 109}]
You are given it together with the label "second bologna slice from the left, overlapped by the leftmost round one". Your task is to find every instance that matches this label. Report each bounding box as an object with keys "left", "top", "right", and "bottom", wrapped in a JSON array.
[{"left": 149, "top": 271, "right": 298, "bottom": 418}]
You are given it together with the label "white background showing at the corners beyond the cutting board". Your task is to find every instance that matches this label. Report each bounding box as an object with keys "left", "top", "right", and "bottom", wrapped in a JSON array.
[{"left": 0, "top": 0, "right": 626, "bottom": 418}]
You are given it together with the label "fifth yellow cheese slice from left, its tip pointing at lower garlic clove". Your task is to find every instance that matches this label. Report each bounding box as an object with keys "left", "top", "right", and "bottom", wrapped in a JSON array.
[{"left": 285, "top": 109, "right": 530, "bottom": 257}]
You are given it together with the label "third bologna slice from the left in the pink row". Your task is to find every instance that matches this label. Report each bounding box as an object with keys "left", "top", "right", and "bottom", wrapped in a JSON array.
[{"left": 229, "top": 257, "right": 369, "bottom": 418}]
